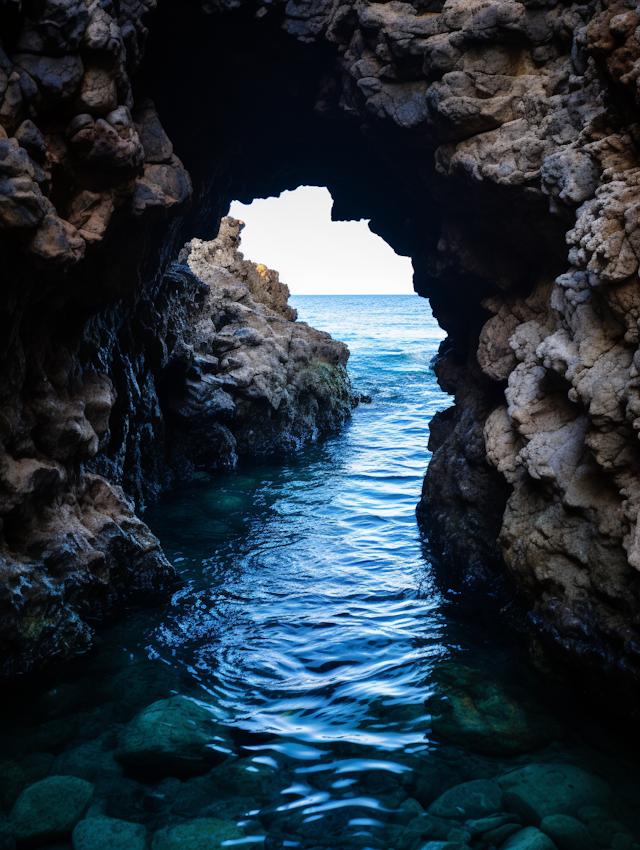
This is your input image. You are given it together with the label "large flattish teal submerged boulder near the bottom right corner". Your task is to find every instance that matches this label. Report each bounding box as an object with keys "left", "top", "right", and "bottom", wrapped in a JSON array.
[{"left": 497, "top": 764, "right": 615, "bottom": 826}]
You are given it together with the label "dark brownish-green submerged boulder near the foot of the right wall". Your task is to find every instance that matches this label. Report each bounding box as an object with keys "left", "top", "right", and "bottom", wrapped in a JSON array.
[{"left": 427, "top": 664, "right": 562, "bottom": 755}]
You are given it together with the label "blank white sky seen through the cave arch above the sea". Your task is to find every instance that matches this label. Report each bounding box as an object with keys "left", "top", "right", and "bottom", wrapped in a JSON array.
[{"left": 229, "top": 186, "right": 413, "bottom": 295}]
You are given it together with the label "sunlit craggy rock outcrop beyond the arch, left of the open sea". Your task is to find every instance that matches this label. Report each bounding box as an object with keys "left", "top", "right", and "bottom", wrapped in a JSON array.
[{"left": 165, "top": 218, "right": 356, "bottom": 477}]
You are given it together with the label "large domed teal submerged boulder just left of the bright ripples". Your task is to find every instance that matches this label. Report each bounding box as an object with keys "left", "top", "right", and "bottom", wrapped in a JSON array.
[{"left": 115, "top": 696, "right": 228, "bottom": 775}]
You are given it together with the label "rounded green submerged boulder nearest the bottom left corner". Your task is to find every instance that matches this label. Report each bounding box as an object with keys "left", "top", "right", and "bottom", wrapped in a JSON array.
[{"left": 9, "top": 776, "right": 93, "bottom": 846}]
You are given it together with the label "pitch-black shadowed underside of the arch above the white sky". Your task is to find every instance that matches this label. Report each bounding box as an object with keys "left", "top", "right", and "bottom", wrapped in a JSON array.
[{"left": 134, "top": 4, "right": 495, "bottom": 362}]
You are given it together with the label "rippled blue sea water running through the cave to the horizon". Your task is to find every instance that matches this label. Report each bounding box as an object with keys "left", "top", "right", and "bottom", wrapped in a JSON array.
[{"left": 0, "top": 296, "right": 640, "bottom": 850}]
